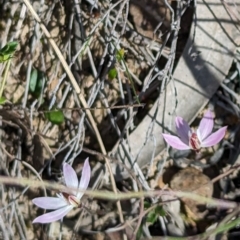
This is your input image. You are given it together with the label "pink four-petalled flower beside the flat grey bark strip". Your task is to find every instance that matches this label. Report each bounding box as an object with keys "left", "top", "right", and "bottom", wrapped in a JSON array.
[{"left": 162, "top": 110, "right": 227, "bottom": 152}]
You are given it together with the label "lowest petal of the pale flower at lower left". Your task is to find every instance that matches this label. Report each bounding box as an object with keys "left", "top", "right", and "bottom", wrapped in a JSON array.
[{"left": 33, "top": 206, "right": 73, "bottom": 223}]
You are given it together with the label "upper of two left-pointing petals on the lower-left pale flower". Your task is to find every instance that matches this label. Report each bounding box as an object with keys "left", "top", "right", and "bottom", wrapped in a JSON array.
[{"left": 32, "top": 197, "right": 68, "bottom": 209}]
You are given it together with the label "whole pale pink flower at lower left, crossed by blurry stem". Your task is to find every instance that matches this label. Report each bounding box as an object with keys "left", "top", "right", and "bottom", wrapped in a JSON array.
[{"left": 32, "top": 158, "right": 91, "bottom": 223}]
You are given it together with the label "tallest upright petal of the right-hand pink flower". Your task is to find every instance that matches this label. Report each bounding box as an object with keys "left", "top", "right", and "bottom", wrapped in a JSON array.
[{"left": 197, "top": 110, "right": 214, "bottom": 142}]
